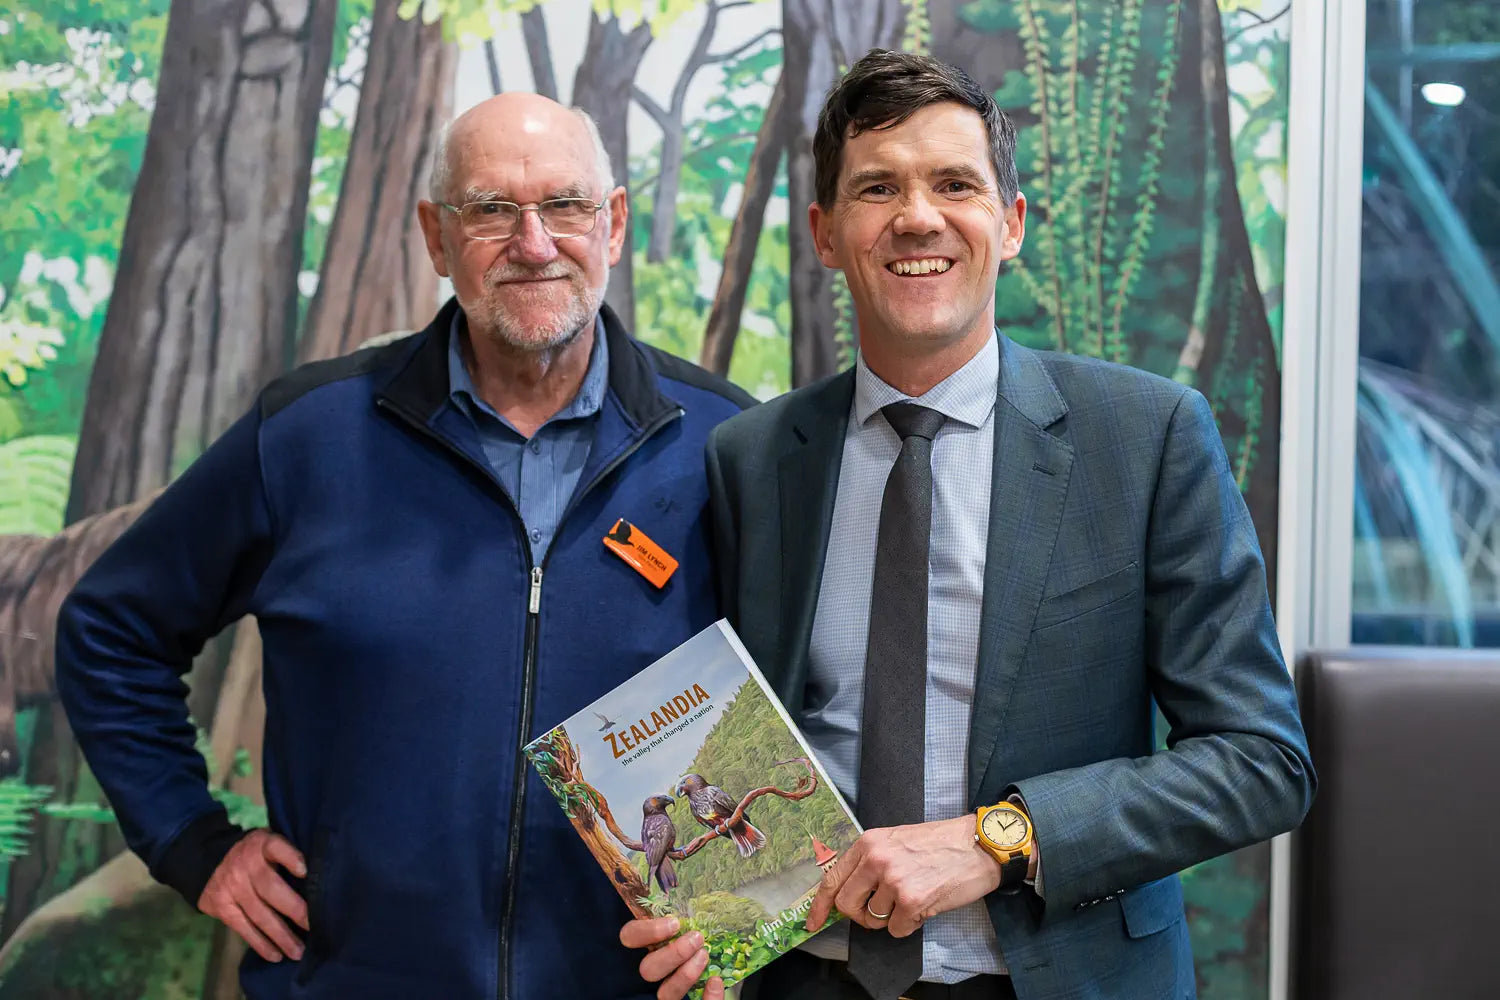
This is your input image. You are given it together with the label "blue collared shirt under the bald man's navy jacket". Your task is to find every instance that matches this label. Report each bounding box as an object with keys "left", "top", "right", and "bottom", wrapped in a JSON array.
[{"left": 449, "top": 312, "right": 609, "bottom": 565}]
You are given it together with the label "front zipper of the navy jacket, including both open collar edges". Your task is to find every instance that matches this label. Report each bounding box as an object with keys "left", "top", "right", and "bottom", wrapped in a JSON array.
[{"left": 377, "top": 399, "right": 684, "bottom": 1000}]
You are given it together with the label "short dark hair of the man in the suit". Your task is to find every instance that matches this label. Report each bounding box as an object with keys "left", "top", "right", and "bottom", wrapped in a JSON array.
[{"left": 813, "top": 48, "right": 1020, "bottom": 208}]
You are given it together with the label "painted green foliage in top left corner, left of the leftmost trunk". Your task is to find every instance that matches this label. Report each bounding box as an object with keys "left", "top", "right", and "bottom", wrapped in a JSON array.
[{"left": 0, "top": 0, "right": 167, "bottom": 534}]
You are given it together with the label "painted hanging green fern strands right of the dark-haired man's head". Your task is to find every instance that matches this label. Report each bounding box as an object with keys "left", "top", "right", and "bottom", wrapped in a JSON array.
[{"left": 968, "top": 0, "right": 1193, "bottom": 367}]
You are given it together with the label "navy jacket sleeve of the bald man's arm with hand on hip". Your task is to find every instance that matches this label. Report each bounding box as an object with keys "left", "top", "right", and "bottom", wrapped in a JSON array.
[{"left": 57, "top": 412, "right": 272, "bottom": 904}]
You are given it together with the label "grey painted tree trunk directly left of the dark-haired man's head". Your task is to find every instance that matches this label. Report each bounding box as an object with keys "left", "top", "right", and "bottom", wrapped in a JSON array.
[{"left": 782, "top": 0, "right": 905, "bottom": 388}]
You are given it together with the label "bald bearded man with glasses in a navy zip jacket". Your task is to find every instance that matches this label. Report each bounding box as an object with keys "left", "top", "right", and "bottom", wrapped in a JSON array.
[{"left": 57, "top": 94, "right": 749, "bottom": 1000}]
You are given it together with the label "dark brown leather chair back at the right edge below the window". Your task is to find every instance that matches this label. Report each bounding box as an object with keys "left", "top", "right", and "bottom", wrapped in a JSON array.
[{"left": 1292, "top": 646, "right": 1500, "bottom": 1000}]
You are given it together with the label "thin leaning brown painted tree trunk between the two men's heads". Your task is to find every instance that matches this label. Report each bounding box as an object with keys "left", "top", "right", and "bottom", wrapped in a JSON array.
[{"left": 699, "top": 73, "right": 800, "bottom": 375}]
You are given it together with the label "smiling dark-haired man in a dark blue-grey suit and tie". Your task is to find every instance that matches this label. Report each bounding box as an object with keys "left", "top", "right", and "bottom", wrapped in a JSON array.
[{"left": 623, "top": 51, "right": 1314, "bottom": 1000}]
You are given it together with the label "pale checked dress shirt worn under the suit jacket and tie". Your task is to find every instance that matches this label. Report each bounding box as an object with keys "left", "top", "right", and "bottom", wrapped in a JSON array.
[{"left": 800, "top": 336, "right": 1005, "bottom": 984}]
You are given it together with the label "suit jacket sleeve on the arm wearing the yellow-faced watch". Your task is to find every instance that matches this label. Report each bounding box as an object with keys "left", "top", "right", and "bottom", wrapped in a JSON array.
[{"left": 1007, "top": 391, "right": 1316, "bottom": 921}]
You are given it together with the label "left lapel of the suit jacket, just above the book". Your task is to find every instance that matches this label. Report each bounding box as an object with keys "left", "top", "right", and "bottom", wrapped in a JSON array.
[{"left": 777, "top": 369, "right": 854, "bottom": 718}]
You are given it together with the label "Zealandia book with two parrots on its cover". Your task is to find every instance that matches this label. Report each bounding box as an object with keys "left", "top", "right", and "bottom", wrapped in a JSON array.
[{"left": 525, "top": 621, "right": 861, "bottom": 996}]
